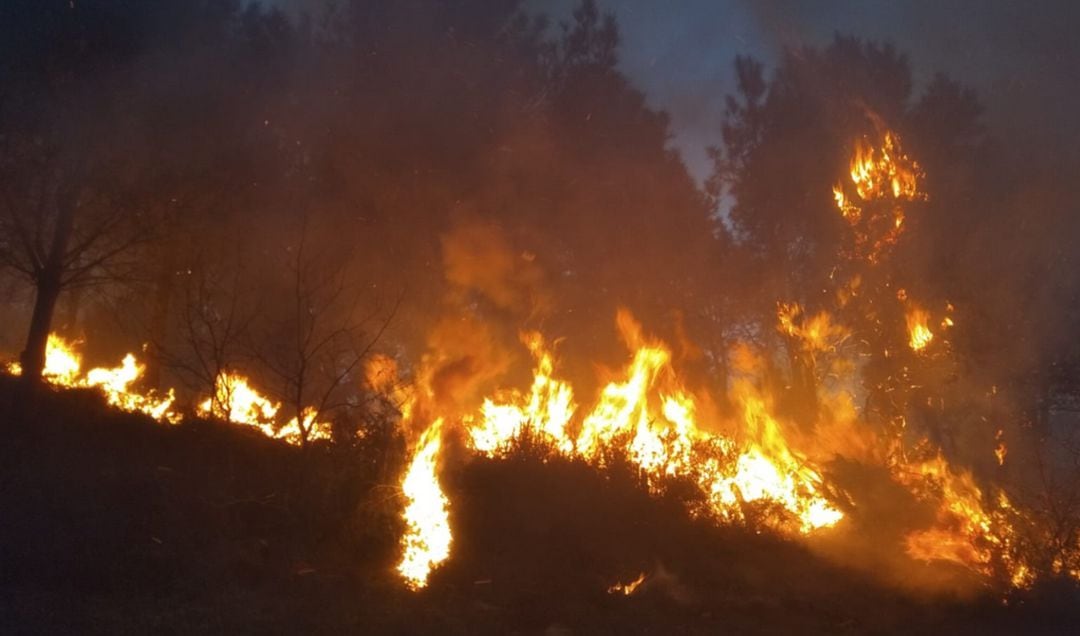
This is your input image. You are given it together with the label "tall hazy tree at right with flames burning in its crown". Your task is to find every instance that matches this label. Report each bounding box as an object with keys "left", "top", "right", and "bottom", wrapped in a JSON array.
[{"left": 710, "top": 36, "right": 981, "bottom": 447}]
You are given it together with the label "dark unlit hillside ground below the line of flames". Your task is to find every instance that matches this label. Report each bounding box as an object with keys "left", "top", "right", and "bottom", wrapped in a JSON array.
[{"left": 0, "top": 379, "right": 1080, "bottom": 635}]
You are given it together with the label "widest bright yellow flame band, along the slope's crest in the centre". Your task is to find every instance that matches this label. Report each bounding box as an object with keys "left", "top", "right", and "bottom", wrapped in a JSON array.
[{"left": 462, "top": 311, "right": 843, "bottom": 533}]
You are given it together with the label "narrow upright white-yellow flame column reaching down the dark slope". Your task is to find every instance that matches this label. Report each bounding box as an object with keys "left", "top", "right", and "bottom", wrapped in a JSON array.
[{"left": 397, "top": 419, "right": 450, "bottom": 590}]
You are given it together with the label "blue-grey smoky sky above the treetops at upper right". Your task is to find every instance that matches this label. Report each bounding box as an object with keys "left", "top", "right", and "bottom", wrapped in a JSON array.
[{"left": 531, "top": 0, "right": 1080, "bottom": 179}]
